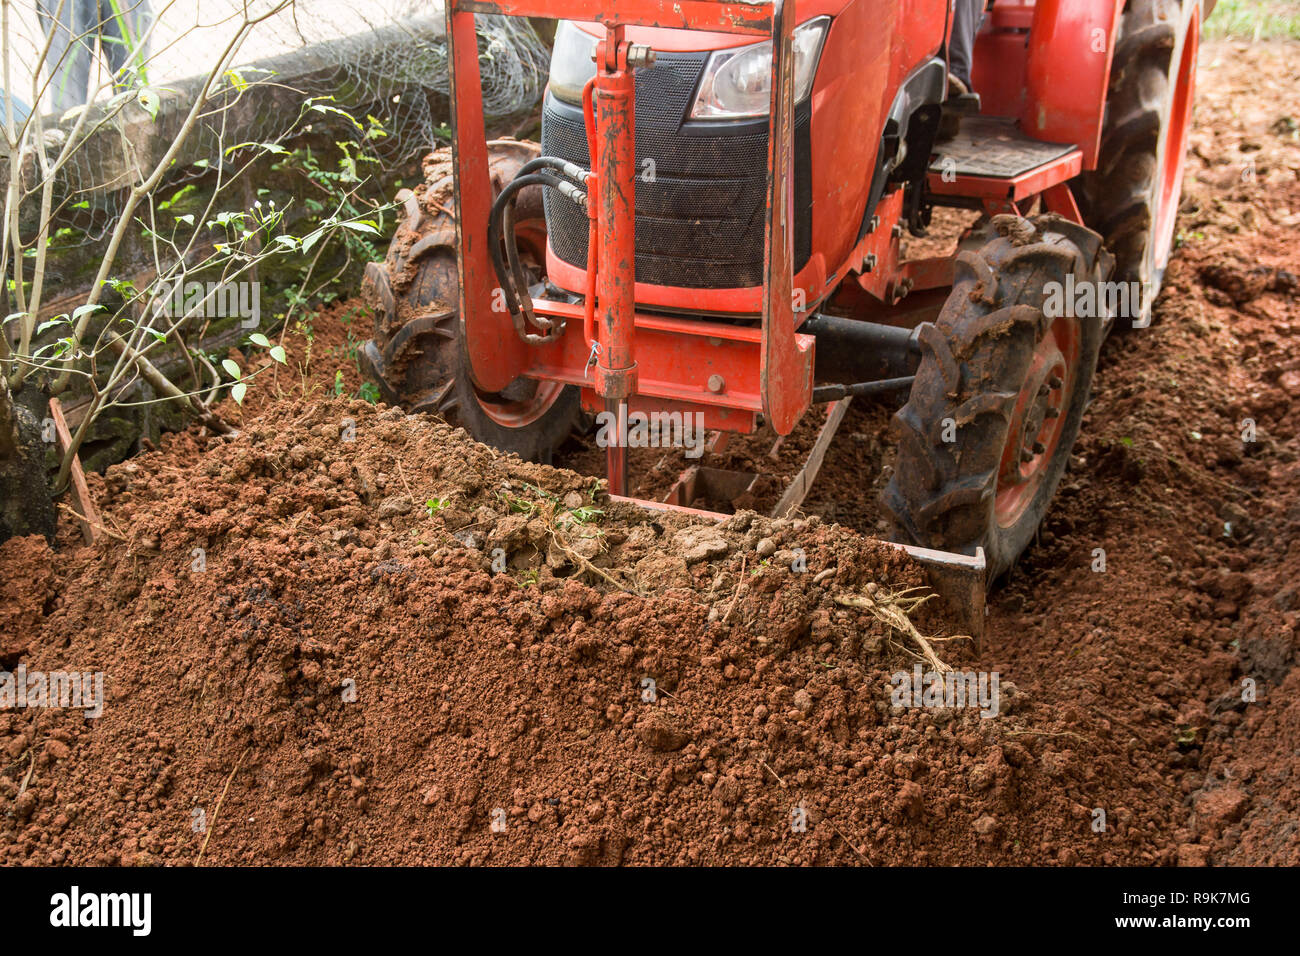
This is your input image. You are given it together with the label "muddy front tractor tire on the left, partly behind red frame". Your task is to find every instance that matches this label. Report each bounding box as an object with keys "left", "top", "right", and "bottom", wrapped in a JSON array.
[{"left": 360, "top": 139, "right": 581, "bottom": 463}]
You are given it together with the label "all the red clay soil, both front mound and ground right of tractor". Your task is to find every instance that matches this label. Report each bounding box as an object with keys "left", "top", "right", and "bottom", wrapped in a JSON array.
[{"left": 0, "top": 44, "right": 1300, "bottom": 865}]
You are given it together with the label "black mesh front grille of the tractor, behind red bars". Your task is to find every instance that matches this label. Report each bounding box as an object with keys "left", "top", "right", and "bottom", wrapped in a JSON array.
[{"left": 542, "top": 53, "right": 813, "bottom": 289}]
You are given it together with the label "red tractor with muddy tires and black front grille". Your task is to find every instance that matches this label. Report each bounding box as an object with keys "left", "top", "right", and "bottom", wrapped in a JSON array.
[{"left": 363, "top": 0, "right": 1213, "bottom": 632}]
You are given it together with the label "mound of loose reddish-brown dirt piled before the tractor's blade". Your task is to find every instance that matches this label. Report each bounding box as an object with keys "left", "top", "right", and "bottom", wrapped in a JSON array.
[{"left": 0, "top": 401, "right": 1206, "bottom": 864}]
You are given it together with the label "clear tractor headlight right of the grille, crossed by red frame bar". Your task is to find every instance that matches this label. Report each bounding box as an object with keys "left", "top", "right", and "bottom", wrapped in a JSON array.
[{"left": 696, "top": 17, "right": 831, "bottom": 120}]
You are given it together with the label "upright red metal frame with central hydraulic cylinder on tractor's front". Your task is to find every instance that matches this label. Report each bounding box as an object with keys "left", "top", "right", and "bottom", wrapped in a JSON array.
[{"left": 446, "top": 0, "right": 813, "bottom": 444}]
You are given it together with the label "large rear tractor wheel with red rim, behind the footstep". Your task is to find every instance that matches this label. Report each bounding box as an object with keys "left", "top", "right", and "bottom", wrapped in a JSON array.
[{"left": 1071, "top": 0, "right": 1199, "bottom": 329}]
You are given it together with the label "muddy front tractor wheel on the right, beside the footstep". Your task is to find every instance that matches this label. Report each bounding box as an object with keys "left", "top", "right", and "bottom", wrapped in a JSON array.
[{"left": 881, "top": 216, "right": 1113, "bottom": 584}]
